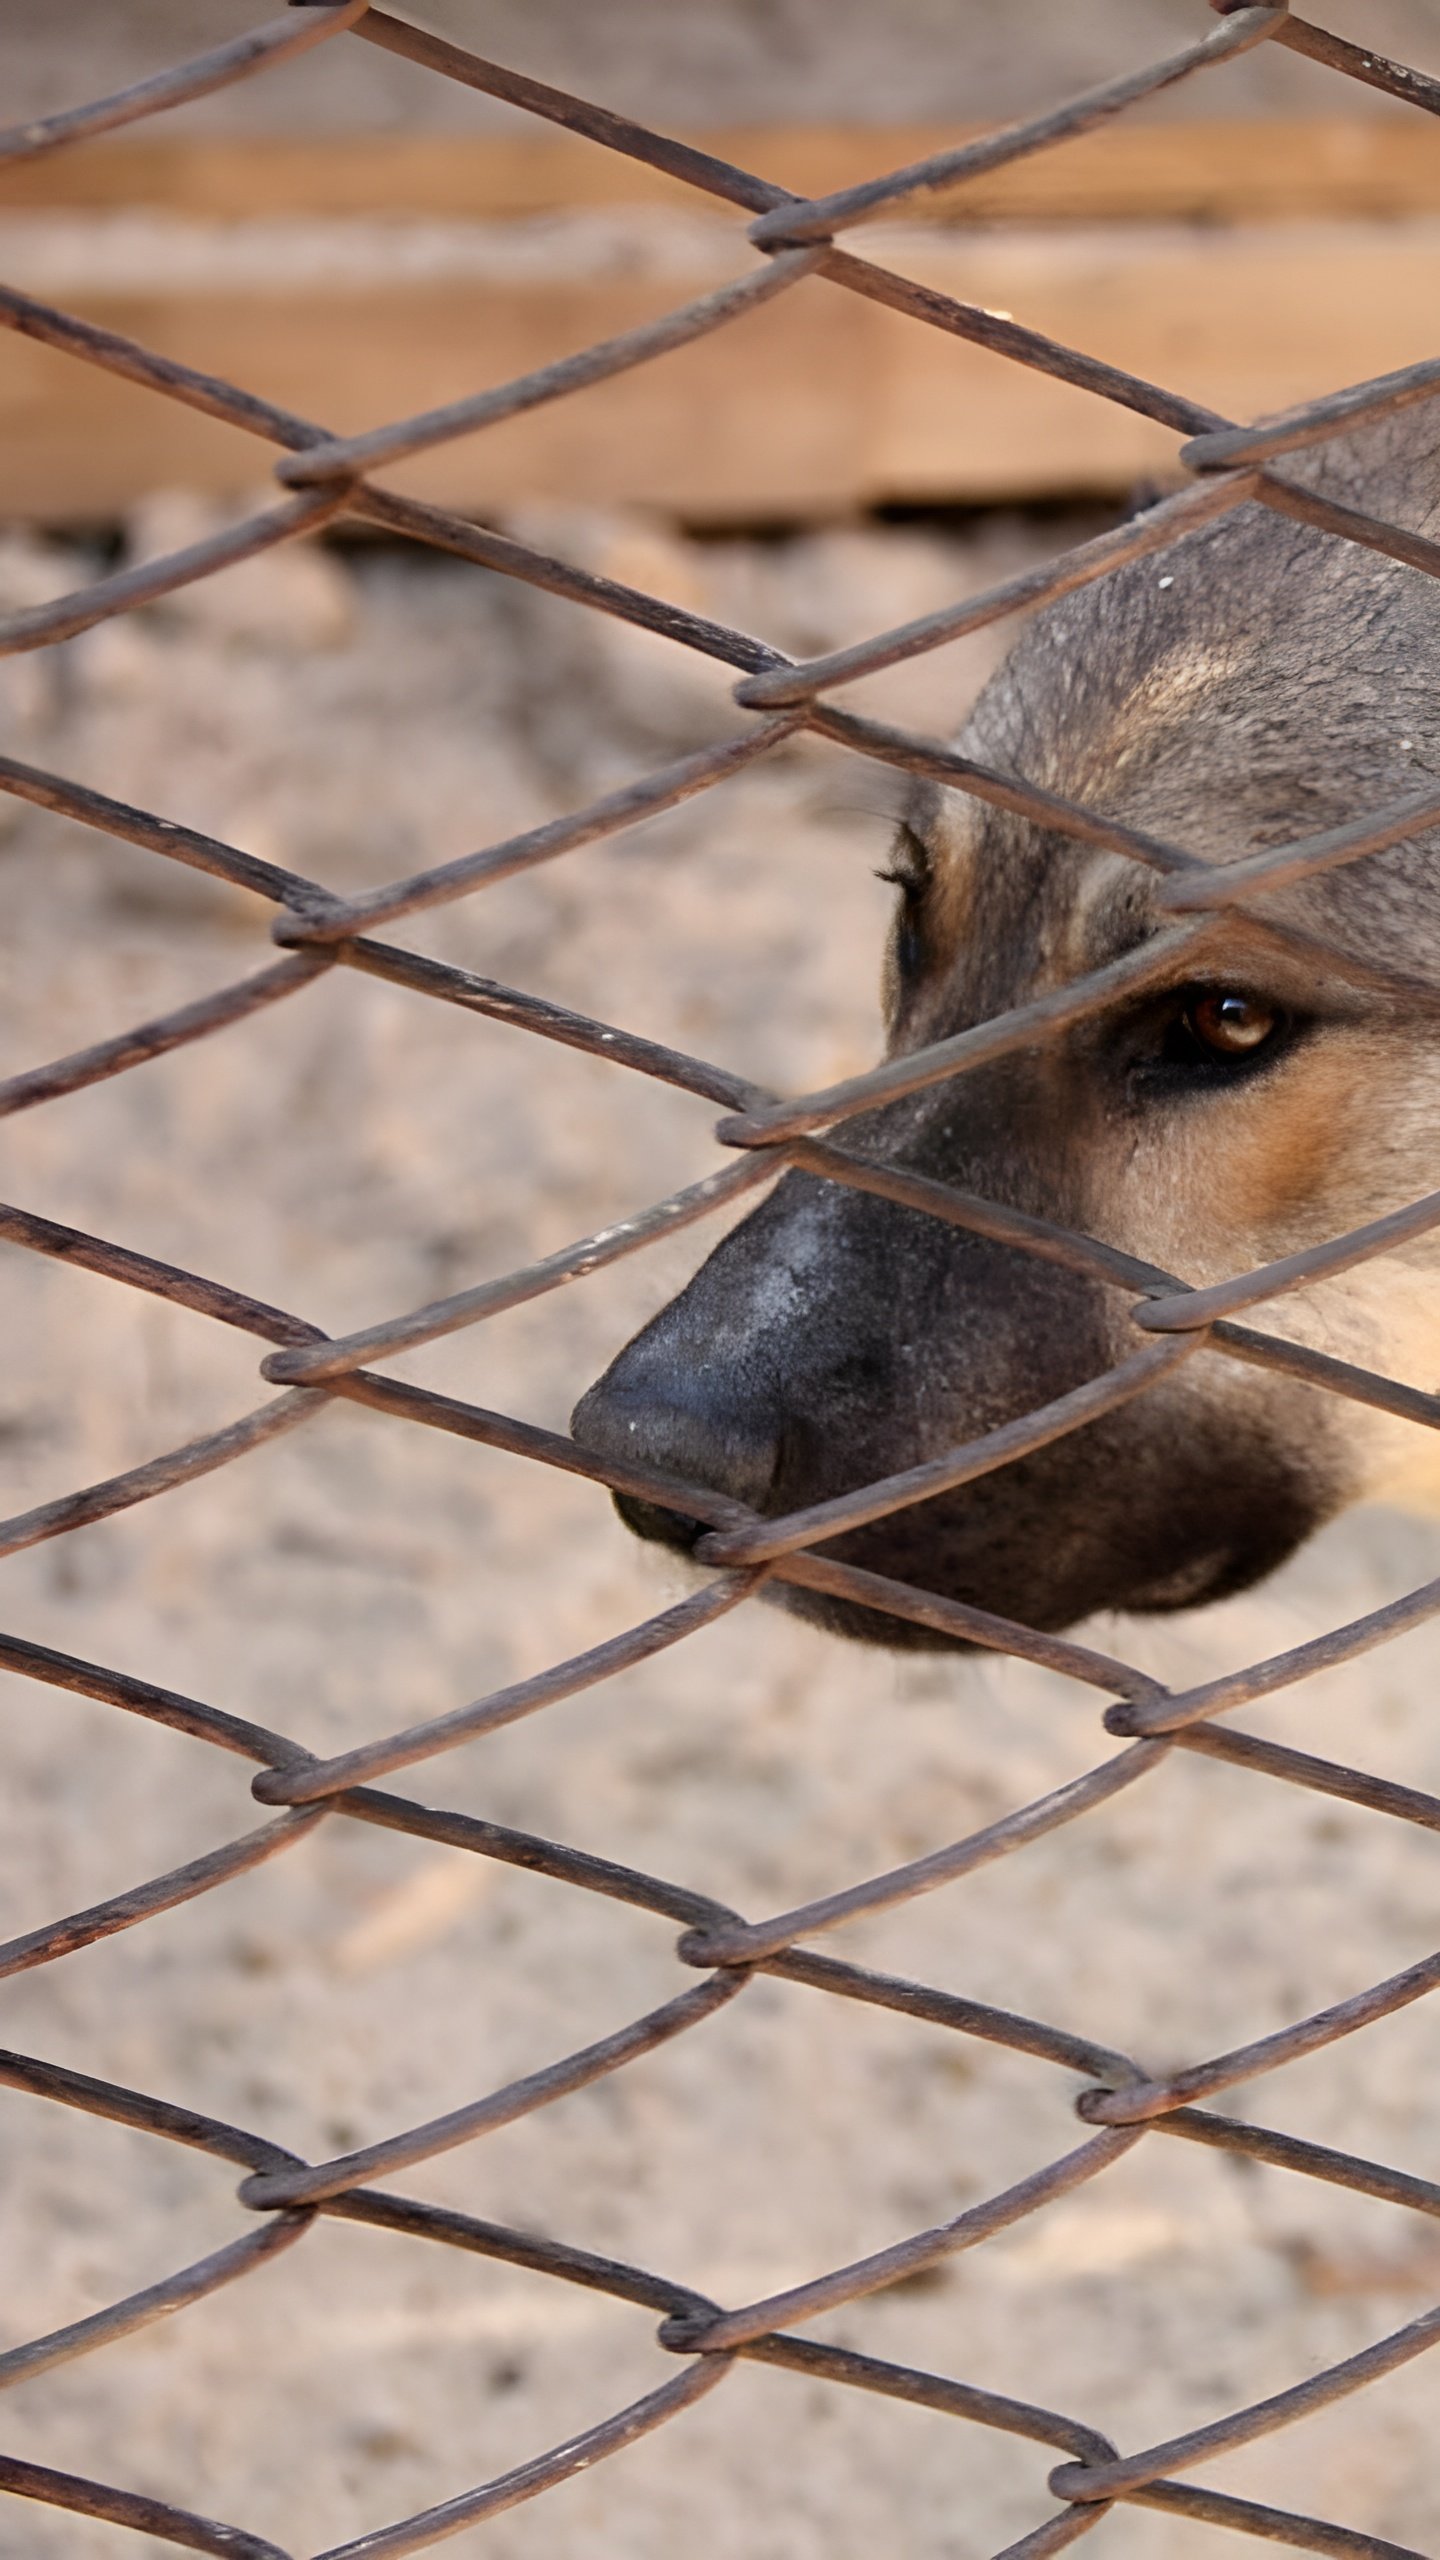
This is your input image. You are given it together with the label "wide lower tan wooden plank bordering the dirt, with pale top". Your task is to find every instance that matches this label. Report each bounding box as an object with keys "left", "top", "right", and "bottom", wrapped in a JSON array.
[{"left": 0, "top": 215, "right": 1440, "bottom": 522}]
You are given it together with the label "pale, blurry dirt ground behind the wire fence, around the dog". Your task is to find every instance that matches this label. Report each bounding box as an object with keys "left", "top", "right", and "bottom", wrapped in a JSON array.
[{"left": 0, "top": 499, "right": 1440, "bottom": 2560}]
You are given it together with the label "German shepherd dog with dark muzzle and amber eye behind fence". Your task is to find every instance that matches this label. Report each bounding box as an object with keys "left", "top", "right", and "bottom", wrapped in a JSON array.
[{"left": 574, "top": 404, "right": 1440, "bottom": 1646}]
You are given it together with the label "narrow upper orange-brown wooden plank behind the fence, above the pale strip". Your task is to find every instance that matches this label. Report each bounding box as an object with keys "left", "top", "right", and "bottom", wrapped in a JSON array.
[{"left": 0, "top": 115, "right": 1440, "bottom": 223}]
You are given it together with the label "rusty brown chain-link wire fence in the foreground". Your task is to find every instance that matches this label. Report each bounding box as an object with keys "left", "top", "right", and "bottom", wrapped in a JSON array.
[{"left": 0, "top": 0, "right": 1440, "bottom": 2560}]
